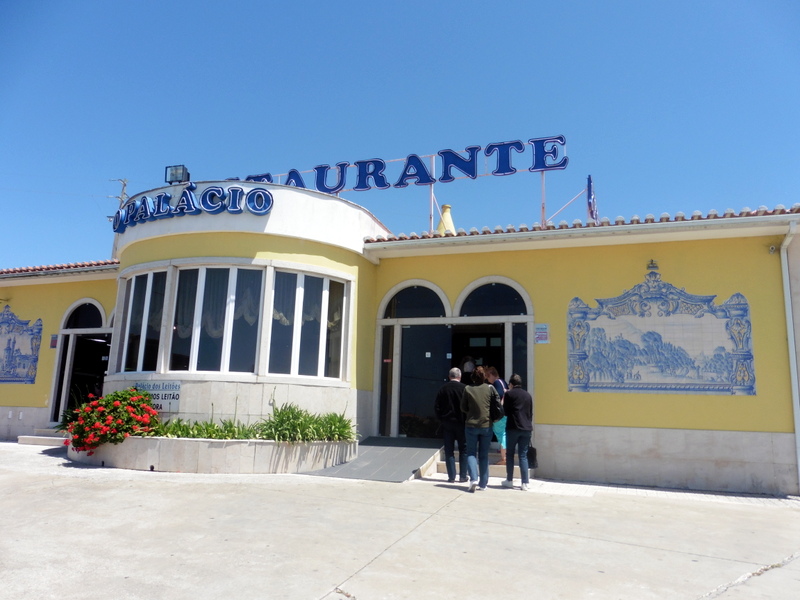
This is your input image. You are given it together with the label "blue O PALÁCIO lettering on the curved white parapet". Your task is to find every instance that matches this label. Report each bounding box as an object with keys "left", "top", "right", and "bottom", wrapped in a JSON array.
[{"left": 113, "top": 182, "right": 273, "bottom": 233}]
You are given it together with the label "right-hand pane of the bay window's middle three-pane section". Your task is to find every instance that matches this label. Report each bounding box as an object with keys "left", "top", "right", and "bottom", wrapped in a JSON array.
[{"left": 229, "top": 269, "right": 263, "bottom": 373}]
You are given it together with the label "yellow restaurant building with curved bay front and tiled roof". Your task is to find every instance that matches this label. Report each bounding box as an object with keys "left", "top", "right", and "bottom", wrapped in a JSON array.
[{"left": 0, "top": 181, "right": 800, "bottom": 494}]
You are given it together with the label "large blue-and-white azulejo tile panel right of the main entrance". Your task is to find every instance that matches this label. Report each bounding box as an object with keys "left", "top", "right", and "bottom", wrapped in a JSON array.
[{"left": 567, "top": 268, "right": 756, "bottom": 395}]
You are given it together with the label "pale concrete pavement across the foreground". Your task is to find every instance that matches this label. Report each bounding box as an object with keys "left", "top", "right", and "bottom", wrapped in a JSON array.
[{"left": 0, "top": 443, "right": 800, "bottom": 600}]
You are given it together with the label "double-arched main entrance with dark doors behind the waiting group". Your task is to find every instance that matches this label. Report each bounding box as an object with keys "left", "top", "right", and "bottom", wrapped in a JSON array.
[{"left": 378, "top": 278, "right": 533, "bottom": 437}]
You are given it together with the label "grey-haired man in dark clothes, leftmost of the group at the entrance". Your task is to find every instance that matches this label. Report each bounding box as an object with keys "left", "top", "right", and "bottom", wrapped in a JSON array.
[{"left": 433, "top": 367, "right": 467, "bottom": 483}]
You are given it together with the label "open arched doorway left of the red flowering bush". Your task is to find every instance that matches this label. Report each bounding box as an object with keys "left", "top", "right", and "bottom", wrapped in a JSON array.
[{"left": 50, "top": 300, "right": 111, "bottom": 422}]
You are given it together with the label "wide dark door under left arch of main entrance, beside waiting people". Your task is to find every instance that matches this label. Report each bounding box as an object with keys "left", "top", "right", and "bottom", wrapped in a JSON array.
[{"left": 399, "top": 325, "right": 452, "bottom": 438}]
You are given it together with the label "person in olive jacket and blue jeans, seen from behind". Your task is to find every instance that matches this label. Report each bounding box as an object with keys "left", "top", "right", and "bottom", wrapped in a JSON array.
[{"left": 461, "top": 367, "right": 500, "bottom": 492}]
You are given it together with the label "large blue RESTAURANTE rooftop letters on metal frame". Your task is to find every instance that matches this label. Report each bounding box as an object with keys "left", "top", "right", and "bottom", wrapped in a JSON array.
[{"left": 246, "top": 135, "right": 569, "bottom": 194}]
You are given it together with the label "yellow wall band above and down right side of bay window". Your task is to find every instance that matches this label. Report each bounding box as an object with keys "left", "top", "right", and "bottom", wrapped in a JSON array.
[{"left": 120, "top": 232, "right": 377, "bottom": 390}]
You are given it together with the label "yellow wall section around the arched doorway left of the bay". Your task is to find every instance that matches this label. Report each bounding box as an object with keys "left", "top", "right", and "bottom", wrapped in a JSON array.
[{"left": 0, "top": 272, "right": 117, "bottom": 407}]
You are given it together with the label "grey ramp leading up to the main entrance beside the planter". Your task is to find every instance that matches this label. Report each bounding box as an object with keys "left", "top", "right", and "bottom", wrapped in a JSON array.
[{"left": 305, "top": 437, "right": 442, "bottom": 483}]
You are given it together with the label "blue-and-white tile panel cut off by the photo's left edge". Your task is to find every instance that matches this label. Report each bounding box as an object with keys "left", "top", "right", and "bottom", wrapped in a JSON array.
[{"left": 0, "top": 305, "right": 42, "bottom": 383}]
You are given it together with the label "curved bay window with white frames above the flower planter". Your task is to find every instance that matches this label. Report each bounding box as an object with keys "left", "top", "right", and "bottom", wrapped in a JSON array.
[{"left": 118, "top": 266, "right": 347, "bottom": 379}]
